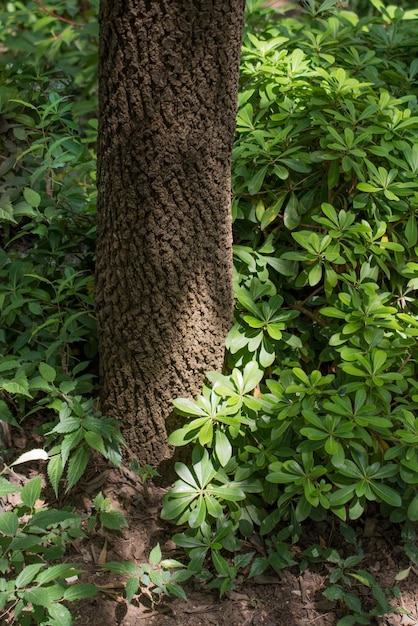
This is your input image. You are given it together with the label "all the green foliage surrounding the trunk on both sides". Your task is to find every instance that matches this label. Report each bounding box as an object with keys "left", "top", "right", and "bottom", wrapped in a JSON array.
[{"left": 0, "top": 0, "right": 418, "bottom": 626}]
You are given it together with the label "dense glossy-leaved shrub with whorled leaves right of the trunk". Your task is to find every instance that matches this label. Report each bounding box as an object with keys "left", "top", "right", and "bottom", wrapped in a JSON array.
[{"left": 163, "top": 1, "right": 418, "bottom": 556}]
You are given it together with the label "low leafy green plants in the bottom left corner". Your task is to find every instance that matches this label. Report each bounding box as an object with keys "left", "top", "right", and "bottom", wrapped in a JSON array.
[{"left": 0, "top": 476, "right": 99, "bottom": 626}]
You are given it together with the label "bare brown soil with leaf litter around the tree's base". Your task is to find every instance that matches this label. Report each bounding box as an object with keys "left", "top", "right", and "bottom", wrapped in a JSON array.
[{"left": 5, "top": 416, "right": 418, "bottom": 626}]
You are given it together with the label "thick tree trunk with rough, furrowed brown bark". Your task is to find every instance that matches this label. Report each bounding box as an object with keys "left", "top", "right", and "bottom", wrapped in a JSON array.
[{"left": 96, "top": 0, "right": 244, "bottom": 465}]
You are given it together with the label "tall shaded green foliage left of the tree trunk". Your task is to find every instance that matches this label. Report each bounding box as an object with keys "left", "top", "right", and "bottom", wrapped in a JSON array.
[{"left": 0, "top": 1, "right": 122, "bottom": 494}]
